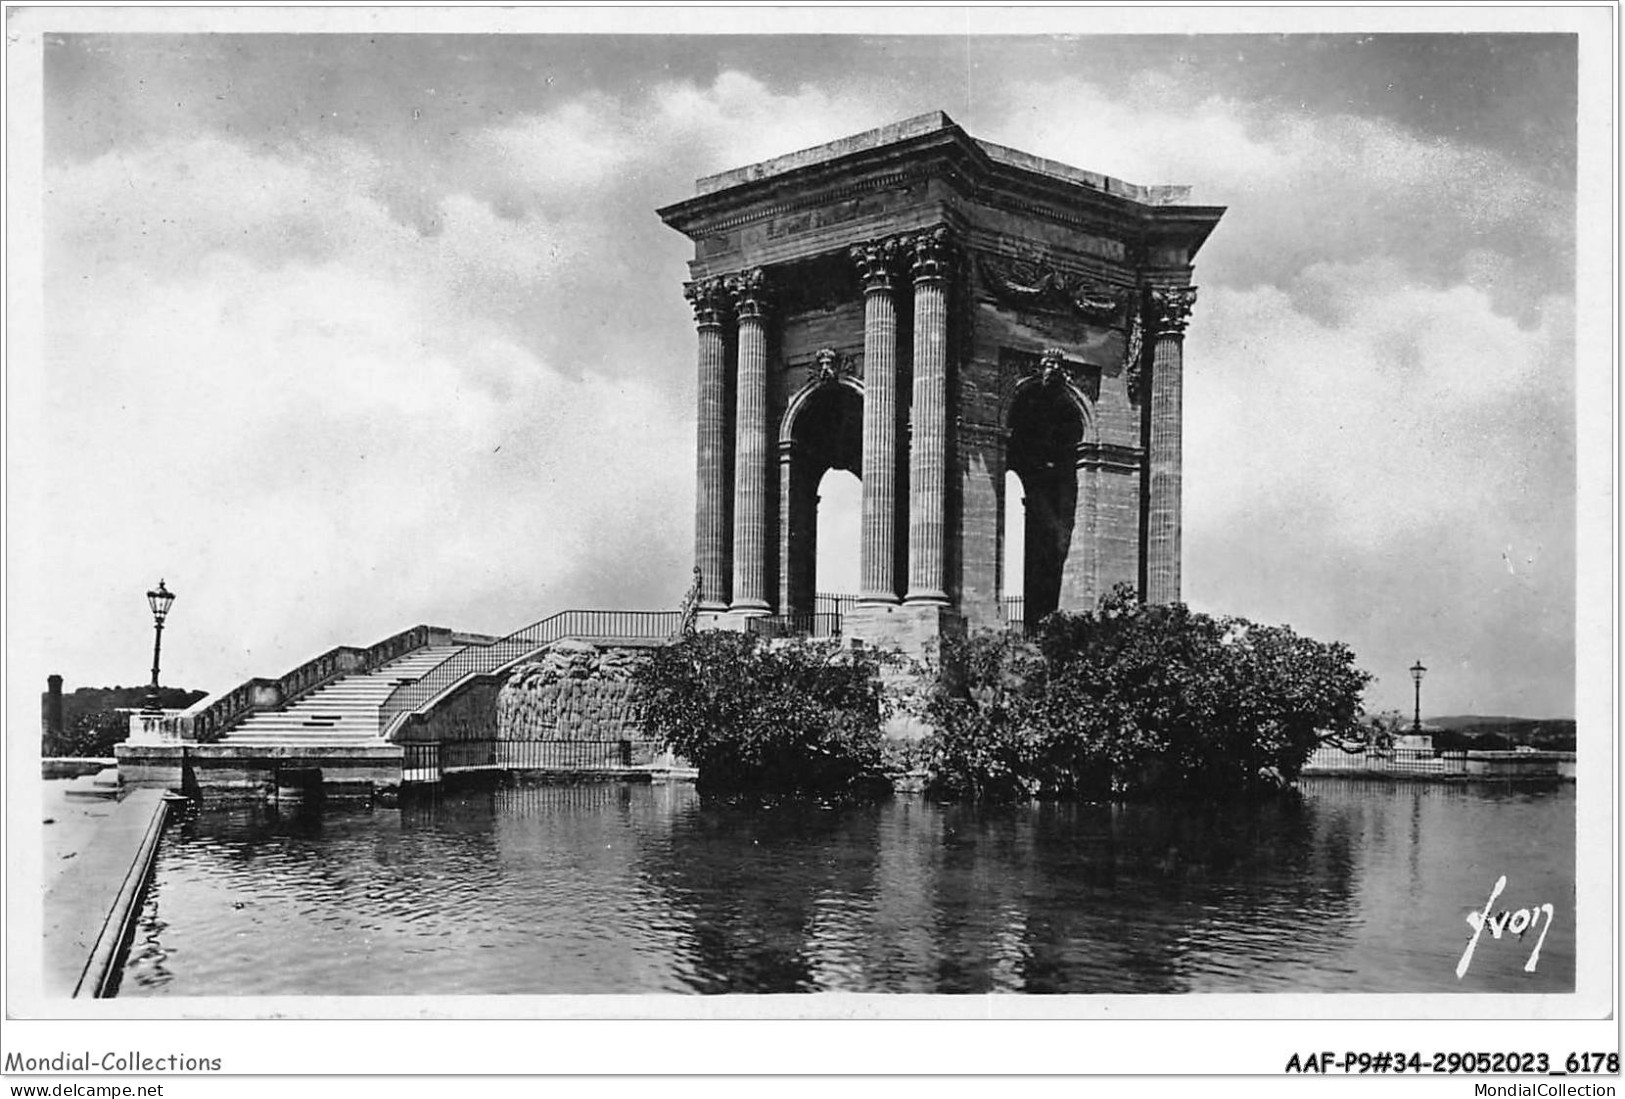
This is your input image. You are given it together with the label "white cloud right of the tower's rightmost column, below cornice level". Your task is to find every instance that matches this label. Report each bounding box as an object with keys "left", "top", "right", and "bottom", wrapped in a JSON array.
[{"left": 1186, "top": 263, "right": 1571, "bottom": 550}]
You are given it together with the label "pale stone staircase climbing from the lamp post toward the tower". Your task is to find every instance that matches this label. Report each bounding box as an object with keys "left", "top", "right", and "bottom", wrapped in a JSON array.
[{"left": 219, "top": 644, "right": 463, "bottom": 748}]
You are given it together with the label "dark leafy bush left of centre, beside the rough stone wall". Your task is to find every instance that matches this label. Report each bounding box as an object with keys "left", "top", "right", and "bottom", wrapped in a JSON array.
[{"left": 634, "top": 631, "right": 882, "bottom": 793}]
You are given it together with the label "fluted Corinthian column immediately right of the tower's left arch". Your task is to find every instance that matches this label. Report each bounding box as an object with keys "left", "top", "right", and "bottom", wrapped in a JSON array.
[{"left": 852, "top": 239, "right": 899, "bottom": 603}]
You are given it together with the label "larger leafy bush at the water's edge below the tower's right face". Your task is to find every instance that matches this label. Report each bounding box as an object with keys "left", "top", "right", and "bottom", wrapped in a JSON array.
[{"left": 931, "top": 587, "right": 1370, "bottom": 798}]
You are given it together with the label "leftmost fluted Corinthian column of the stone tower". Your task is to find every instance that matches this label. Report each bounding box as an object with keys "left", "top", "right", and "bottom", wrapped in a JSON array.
[{"left": 683, "top": 278, "right": 733, "bottom": 611}]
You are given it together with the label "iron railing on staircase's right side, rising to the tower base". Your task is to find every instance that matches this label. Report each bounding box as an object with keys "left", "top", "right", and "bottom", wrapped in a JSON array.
[{"left": 379, "top": 611, "right": 683, "bottom": 740}]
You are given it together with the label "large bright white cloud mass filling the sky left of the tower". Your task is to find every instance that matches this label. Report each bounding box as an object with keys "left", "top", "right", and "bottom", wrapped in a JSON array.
[{"left": 31, "top": 126, "right": 692, "bottom": 689}]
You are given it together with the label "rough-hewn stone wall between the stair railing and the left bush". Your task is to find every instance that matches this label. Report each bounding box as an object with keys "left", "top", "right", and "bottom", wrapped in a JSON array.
[{"left": 497, "top": 641, "right": 644, "bottom": 740}]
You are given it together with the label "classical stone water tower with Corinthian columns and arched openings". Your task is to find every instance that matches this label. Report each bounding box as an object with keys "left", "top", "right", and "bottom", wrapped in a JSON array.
[{"left": 660, "top": 112, "right": 1224, "bottom": 650}]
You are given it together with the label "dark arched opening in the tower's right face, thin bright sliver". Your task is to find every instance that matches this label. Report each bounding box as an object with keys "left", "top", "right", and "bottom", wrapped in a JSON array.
[{"left": 1006, "top": 382, "right": 1084, "bottom": 624}]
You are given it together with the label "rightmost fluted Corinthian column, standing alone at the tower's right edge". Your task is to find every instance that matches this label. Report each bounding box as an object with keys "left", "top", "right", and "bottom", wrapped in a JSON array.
[{"left": 1146, "top": 286, "right": 1196, "bottom": 603}]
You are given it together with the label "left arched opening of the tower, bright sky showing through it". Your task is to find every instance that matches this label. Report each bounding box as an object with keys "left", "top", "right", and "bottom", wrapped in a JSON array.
[{"left": 778, "top": 382, "right": 863, "bottom": 615}]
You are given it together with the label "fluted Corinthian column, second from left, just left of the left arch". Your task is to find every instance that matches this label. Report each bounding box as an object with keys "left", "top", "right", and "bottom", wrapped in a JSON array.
[{"left": 728, "top": 267, "right": 772, "bottom": 615}]
